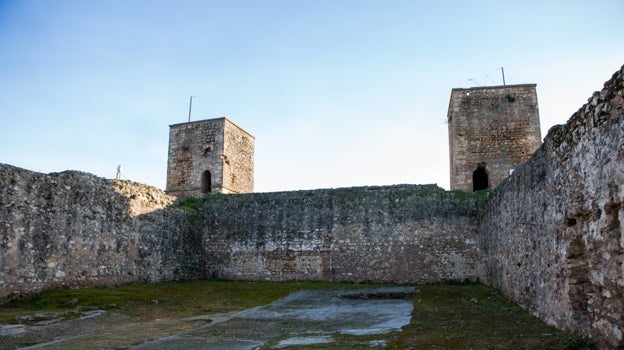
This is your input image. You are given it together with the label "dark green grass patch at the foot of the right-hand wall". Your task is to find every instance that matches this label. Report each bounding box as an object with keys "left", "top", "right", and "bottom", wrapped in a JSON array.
[{"left": 388, "top": 283, "right": 596, "bottom": 350}]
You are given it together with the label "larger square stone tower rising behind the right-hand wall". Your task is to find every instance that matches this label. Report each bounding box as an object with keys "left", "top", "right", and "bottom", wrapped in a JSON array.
[{"left": 448, "top": 84, "right": 541, "bottom": 191}]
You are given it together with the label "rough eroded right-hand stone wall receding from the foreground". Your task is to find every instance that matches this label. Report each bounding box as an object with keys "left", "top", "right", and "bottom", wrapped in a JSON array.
[{"left": 480, "top": 67, "right": 624, "bottom": 348}]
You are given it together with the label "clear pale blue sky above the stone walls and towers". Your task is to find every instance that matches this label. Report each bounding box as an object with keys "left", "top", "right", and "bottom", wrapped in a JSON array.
[{"left": 0, "top": 0, "right": 624, "bottom": 191}]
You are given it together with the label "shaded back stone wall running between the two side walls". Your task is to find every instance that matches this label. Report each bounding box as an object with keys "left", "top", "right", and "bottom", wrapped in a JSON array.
[{"left": 201, "top": 185, "right": 483, "bottom": 283}]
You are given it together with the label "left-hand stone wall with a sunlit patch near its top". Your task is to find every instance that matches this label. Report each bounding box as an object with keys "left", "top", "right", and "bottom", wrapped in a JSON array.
[{"left": 0, "top": 164, "right": 201, "bottom": 300}]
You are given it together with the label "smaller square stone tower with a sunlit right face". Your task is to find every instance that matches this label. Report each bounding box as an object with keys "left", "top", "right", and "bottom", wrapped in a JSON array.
[{"left": 166, "top": 118, "right": 255, "bottom": 198}]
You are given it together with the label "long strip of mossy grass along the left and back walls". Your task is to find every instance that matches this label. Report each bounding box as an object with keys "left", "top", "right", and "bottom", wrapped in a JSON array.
[{"left": 0, "top": 280, "right": 386, "bottom": 324}]
